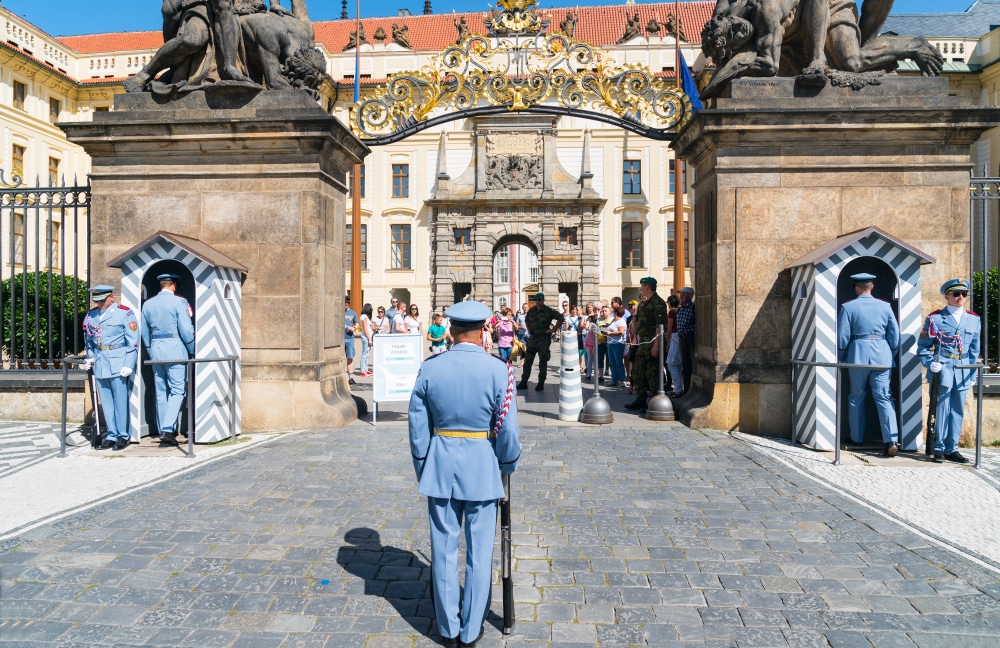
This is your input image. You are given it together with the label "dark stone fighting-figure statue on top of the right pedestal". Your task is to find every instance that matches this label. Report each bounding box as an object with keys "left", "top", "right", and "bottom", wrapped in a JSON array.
[{"left": 701, "top": 0, "right": 944, "bottom": 97}]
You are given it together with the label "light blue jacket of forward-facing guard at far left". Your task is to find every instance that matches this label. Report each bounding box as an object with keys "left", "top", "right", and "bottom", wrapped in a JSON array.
[{"left": 83, "top": 304, "right": 139, "bottom": 379}]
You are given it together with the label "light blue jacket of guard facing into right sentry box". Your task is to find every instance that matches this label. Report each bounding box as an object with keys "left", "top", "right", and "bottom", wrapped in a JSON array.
[{"left": 837, "top": 295, "right": 899, "bottom": 367}]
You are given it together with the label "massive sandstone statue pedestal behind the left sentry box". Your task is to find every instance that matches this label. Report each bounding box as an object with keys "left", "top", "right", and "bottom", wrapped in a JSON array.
[{"left": 61, "top": 86, "right": 368, "bottom": 431}]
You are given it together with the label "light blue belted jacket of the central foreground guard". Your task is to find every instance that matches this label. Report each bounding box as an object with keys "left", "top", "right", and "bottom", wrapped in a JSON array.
[{"left": 409, "top": 343, "right": 521, "bottom": 502}]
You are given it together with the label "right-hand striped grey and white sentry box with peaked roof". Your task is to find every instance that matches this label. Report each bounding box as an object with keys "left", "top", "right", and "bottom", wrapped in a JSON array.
[{"left": 786, "top": 227, "right": 934, "bottom": 451}]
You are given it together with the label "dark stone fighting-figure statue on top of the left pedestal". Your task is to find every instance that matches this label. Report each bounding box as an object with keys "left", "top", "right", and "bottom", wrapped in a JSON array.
[{"left": 125, "top": 0, "right": 326, "bottom": 95}]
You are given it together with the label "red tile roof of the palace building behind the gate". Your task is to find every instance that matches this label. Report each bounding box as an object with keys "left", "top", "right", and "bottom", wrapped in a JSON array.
[{"left": 58, "top": 2, "right": 715, "bottom": 54}]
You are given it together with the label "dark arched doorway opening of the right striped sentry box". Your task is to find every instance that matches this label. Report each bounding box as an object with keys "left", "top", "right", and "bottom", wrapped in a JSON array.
[{"left": 837, "top": 257, "right": 902, "bottom": 446}]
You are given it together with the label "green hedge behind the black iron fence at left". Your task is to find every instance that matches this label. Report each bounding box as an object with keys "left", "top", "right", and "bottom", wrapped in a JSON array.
[{"left": 0, "top": 270, "right": 90, "bottom": 359}]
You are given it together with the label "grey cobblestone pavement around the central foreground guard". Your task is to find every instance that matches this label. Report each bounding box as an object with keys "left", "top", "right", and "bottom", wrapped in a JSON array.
[{"left": 0, "top": 414, "right": 1000, "bottom": 648}]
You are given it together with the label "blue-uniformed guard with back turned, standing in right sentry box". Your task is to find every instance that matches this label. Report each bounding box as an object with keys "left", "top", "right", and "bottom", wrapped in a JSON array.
[{"left": 837, "top": 272, "right": 899, "bottom": 457}]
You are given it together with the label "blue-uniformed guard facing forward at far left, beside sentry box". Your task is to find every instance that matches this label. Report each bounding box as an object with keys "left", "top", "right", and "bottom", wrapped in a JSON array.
[{"left": 83, "top": 285, "right": 139, "bottom": 450}]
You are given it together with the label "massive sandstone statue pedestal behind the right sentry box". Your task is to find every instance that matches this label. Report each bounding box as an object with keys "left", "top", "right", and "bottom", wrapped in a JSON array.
[{"left": 674, "top": 75, "right": 1000, "bottom": 438}]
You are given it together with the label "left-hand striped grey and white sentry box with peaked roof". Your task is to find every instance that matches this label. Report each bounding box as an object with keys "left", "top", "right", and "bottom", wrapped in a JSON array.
[{"left": 108, "top": 232, "right": 247, "bottom": 443}]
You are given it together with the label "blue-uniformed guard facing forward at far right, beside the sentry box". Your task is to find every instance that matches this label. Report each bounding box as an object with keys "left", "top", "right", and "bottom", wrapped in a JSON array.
[{"left": 917, "top": 278, "right": 982, "bottom": 463}]
